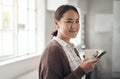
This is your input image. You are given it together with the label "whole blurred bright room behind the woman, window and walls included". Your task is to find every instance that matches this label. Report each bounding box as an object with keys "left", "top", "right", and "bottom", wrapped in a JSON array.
[{"left": 0, "top": 0, "right": 120, "bottom": 79}]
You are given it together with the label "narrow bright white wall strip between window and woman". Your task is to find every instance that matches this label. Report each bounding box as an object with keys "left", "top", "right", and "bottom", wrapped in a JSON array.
[{"left": 36, "top": 0, "right": 46, "bottom": 53}]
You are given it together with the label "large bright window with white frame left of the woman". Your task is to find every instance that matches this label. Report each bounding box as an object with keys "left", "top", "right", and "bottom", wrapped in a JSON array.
[{"left": 0, "top": 0, "right": 37, "bottom": 59}]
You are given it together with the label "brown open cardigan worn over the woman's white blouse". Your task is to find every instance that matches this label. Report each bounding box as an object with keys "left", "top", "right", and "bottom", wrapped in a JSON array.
[{"left": 39, "top": 40, "right": 90, "bottom": 79}]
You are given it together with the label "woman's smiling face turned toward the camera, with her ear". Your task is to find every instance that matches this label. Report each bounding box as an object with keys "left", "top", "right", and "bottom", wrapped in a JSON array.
[{"left": 56, "top": 10, "right": 80, "bottom": 39}]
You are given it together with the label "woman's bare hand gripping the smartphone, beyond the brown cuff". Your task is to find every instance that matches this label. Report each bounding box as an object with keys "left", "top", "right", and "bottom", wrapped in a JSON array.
[{"left": 80, "top": 58, "right": 99, "bottom": 73}]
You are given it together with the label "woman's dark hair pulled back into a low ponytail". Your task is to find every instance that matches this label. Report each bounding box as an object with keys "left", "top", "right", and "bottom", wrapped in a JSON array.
[{"left": 52, "top": 4, "right": 79, "bottom": 37}]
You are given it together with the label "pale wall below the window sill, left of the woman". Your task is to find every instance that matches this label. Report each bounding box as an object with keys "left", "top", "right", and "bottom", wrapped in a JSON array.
[{"left": 0, "top": 55, "right": 40, "bottom": 79}]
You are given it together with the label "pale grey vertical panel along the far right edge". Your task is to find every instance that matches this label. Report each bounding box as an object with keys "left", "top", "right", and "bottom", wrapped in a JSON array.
[{"left": 112, "top": 0, "right": 120, "bottom": 72}]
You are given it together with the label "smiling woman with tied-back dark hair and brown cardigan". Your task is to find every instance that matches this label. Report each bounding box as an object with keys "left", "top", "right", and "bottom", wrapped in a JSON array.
[{"left": 39, "top": 5, "right": 99, "bottom": 79}]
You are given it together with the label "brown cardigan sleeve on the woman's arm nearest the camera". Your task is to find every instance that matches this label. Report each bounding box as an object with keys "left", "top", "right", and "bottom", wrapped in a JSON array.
[{"left": 39, "top": 46, "right": 85, "bottom": 79}]
